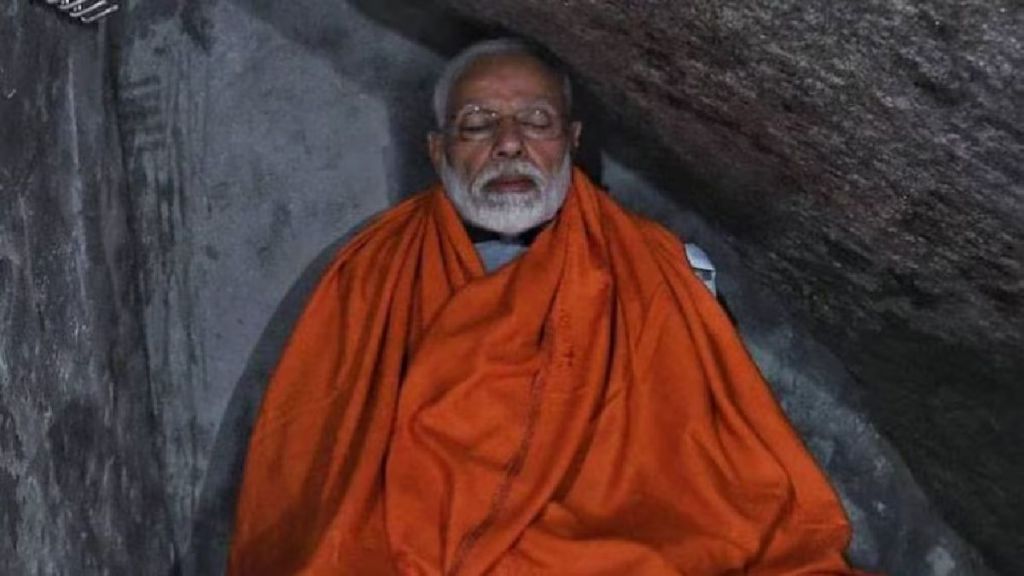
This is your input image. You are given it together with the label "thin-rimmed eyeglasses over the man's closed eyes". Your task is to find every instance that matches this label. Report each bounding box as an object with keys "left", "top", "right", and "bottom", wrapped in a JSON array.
[{"left": 449, "top": 106, "right": 565, "bottom": 141}]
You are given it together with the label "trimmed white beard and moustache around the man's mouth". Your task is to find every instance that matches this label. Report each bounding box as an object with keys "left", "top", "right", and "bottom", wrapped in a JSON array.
[{"left": 440, "top": 151, "right": 572, "bottom": 236}]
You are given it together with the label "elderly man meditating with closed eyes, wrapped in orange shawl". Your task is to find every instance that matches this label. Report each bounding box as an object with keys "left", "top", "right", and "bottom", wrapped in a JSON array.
[{"left": 230, "top": 40, "right": 851, "bottom": 575}]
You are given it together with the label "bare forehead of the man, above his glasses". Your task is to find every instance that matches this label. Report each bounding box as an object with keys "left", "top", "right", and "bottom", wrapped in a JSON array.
[{"left": 449, "top": 54, "right": 563, "bottom": 110}]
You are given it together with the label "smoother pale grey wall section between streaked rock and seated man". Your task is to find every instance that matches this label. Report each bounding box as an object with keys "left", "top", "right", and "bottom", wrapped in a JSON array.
[{"left": 112, "top": 2, "right": 439, "bottom": 574}]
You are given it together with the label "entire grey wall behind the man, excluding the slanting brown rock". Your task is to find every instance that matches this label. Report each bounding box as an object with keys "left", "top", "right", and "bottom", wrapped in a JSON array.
[{"left": 0, "top": 0, "right": 1015, "bottom": 576}]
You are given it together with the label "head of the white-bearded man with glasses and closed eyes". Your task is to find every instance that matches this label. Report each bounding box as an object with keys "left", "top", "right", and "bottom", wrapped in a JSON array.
[{"left": 428, "top": 39, "right": 581, "bottom": 235}]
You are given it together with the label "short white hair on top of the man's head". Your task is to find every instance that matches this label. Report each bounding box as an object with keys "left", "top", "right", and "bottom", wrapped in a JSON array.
[{"left": 433, "top": 38, "right": 572, "bottom": 128}]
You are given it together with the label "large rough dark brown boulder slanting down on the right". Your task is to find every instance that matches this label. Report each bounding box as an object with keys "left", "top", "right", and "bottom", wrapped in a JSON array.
[{"left": 432, "top": 0, "right": 1024, "bottom": 573}]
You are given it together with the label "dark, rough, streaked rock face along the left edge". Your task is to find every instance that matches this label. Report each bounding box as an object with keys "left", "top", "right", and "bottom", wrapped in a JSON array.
[{"left": 0, "top": 2, "right": 174, "bottom": 575}]
